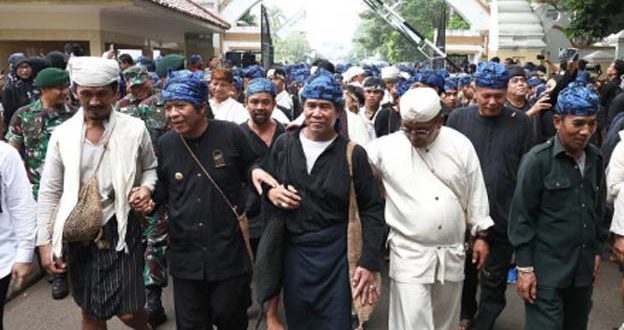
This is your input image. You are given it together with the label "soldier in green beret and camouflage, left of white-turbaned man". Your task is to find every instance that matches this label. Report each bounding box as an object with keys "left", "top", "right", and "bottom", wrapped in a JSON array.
[{"left": 6, "top": 68, "right": 76, "bottom": 299}]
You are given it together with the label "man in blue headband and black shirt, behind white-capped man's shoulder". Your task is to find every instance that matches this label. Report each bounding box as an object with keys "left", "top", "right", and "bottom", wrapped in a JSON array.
[{"left": 447, "top": 62, "right": 532, "bottom": 329}]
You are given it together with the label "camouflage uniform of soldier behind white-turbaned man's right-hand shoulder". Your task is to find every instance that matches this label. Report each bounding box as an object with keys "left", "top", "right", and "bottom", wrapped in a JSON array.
[{"left": 119, "top": 93, "right": 169, "bottom": 287}]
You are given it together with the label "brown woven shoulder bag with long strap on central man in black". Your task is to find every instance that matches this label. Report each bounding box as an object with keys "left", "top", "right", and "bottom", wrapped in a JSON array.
[{"left": 347, "top": 141, "right": 381, "bottom": 329}]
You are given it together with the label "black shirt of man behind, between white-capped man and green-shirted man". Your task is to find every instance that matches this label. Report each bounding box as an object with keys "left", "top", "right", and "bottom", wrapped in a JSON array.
[{"left": 446, "top": 106, "right": 533, "bottom": 238}]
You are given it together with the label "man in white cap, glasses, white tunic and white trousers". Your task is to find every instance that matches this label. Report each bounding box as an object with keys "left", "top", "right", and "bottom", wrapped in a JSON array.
[{"left": 365, "top": 88, "right": 493, "bottom": 330}]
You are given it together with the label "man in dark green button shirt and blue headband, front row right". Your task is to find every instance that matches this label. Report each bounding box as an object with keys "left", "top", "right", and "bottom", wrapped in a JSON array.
[{"left": 508, "top": 83, "right": 607, "bottom": 330}]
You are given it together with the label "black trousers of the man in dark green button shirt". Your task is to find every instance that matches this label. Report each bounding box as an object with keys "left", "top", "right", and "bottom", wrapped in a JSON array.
[{"left": 524, "top": 284, "right": 593, "bottom": 330}]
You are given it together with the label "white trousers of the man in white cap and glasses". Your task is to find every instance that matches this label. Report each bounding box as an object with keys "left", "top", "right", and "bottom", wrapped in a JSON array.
[{"left": 388, "top": 279, "right": 463, "bottom": 330}]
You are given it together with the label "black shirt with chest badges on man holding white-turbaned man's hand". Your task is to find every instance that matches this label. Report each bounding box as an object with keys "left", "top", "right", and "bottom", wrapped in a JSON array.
[{"left": 154, "top": 120, "right": 256, "bottom": 281}]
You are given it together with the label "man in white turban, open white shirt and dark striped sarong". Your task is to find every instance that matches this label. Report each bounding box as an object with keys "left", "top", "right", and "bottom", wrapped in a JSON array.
[{"left": 37, "top": 57, "right": 157, "bottom": 329}]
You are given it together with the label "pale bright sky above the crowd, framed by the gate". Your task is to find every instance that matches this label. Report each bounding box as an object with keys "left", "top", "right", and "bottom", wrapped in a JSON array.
[{"left": 264, "top": 0, "right": 366, "bottom": 57}]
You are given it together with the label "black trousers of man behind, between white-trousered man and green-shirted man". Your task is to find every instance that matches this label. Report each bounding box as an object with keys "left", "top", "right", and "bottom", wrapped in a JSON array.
[{"left": 474, "top": 237, "right": 513, "bottom": 330}]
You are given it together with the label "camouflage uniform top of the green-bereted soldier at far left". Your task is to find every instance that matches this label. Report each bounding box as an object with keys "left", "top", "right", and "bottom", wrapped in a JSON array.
[{"left": 6, "top": 100, "right": 76, "bottom": 200}]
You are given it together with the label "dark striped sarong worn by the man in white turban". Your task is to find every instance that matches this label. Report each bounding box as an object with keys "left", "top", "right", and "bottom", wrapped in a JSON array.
[{"left": 67, "top": 216, "right": 145, "bottom": 320}]
